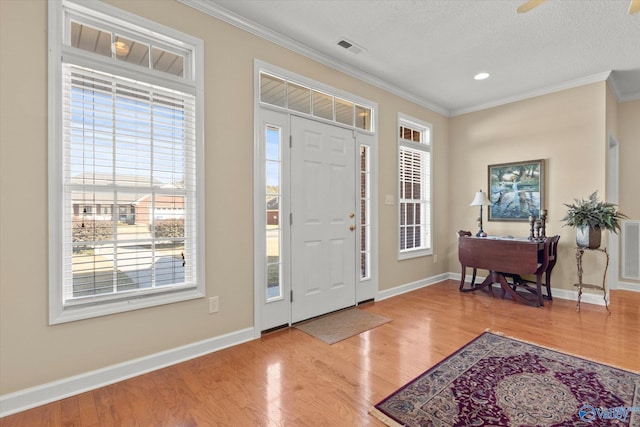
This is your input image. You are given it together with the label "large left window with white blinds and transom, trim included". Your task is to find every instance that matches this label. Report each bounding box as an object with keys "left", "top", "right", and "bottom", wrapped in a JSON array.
[{"left": 49, "top": 1, "right": 204, "bottom": 323}]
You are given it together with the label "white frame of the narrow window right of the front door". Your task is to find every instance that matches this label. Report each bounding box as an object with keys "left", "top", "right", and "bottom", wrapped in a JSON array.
[{"left": 396, "top": 113, "right": 433, "bottom": 260}]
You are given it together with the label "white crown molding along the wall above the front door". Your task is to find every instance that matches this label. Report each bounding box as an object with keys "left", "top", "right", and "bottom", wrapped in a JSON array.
[{"left": 178, "top": 0, "right": 451, "bottom": 117}]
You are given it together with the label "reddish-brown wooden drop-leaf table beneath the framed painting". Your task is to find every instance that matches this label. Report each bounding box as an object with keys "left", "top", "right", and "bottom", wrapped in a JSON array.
[{"left": 458, "top": 236, "right": 549, "bottom": 307}]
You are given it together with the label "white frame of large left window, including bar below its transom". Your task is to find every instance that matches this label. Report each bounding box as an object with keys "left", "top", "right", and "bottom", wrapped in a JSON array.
[{"left": 48, "top": 0, "right": 206, "bottom": 325}]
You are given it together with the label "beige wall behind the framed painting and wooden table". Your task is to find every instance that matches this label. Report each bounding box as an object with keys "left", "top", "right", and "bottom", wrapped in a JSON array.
[{"left": 449, "top": 82, "right": 607, "bottom": 290}]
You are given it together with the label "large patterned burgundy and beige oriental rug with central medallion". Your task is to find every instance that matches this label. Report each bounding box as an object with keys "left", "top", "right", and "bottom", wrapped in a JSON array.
[{"left": 370, "top": 332, "right": 640, "bottom": 427}]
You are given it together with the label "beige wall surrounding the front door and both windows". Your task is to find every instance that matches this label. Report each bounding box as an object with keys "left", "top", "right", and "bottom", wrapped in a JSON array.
[{"left": 0, "top": 0, "right": 448, "bottom": 394}]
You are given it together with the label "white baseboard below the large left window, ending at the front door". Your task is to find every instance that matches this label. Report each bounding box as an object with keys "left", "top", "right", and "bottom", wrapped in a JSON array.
[{"left": 0, "top": 328, "right": 254, "bottom": 418}]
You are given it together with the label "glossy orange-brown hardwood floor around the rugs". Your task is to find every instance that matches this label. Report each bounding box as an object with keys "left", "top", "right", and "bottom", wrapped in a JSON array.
[{"left": 0, "top": 281, "right": 640, "bottom": 427}]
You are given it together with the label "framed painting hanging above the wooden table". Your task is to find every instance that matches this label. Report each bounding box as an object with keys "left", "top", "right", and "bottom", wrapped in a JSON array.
[{"left": 488, "top": 160, "right": 544, "bottom": 222}]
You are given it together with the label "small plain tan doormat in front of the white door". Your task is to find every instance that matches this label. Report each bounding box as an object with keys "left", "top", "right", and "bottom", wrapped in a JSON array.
[{"left": 294, "top": 308, "right": 391, "bottom": 344}]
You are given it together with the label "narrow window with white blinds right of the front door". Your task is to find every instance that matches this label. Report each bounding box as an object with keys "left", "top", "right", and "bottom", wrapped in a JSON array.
[{"left": 398, "top": 117, "right": 432, "bottom": 258}]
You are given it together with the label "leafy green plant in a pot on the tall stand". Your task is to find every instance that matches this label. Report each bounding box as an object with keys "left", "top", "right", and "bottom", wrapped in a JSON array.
[{"left": 562, "top": 191, "right": 627, "bottom": 249}]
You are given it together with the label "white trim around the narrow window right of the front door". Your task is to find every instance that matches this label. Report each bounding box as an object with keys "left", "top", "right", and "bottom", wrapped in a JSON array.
[{"left": 396, "top": 113, "right": 433, "bottom": 260}]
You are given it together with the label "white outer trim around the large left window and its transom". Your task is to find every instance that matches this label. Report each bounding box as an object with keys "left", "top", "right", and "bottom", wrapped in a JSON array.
[{"left": 48, "top": 0, "right": 206, "bottom": 325}]
